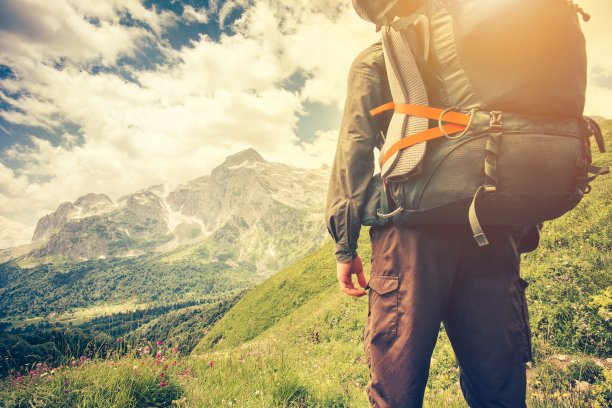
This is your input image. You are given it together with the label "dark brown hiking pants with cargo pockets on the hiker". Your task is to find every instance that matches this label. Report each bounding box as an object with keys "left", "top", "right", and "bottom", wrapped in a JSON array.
[{"left": 364, "top": 223, "right": 532, "bottom": 408}]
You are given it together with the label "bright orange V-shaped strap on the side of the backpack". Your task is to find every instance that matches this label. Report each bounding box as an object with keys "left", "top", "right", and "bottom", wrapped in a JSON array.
[{"left": 370, "top": 102, "right": 473, "bottom": 165}]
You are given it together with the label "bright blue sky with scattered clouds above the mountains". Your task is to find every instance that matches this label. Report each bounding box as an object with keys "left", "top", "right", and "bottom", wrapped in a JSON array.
[{"left": 0, "top": 0, "right": 612, "bottom": 248}]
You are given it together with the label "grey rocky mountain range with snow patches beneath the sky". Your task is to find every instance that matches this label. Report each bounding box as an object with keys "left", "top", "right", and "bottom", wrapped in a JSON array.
[{"left": 23, "top": 149, "right": 329, "bottom": 271}]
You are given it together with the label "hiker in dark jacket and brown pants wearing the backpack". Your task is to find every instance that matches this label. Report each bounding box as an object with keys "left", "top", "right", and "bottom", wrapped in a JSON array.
[{"left": 326, "top": 1, "right": 538, "bottom": 408}]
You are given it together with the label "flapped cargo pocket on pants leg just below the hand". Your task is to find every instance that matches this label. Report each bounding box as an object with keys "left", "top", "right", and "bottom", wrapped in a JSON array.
[{"left": 368, "top": 276, "right": 399, "bottom": 335}]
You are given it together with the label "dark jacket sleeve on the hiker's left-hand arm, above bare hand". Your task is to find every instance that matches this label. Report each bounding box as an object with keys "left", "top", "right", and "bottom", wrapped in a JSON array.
[{"left": 325, "top": 45, "right": 388, "bottom": 262}]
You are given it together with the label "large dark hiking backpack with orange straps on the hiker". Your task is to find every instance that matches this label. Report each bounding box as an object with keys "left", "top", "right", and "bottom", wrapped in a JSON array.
[{"left": 354, "top": 0, "right": 608, "bottom": 246}]
